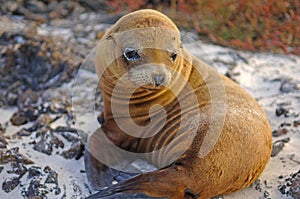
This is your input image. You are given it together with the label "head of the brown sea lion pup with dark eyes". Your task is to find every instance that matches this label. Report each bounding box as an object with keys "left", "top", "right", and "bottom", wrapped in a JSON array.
[{"left": 96, "top": 10, "right": 189, "bottom": 90}]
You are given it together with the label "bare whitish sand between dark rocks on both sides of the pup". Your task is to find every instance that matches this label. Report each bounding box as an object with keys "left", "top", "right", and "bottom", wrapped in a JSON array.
[{"left": 0, "top": 32, "right": 300, "bottom": 199}]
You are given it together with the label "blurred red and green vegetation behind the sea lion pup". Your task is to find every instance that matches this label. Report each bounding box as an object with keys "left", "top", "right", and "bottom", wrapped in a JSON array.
[{"left": 109, "top": 0, "right": 300, "bottom": 55}]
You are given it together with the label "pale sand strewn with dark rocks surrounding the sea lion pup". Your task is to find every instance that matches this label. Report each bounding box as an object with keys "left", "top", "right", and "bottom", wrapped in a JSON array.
[{"left": 0, "top": 1, "right": 300, "bottom": 199}]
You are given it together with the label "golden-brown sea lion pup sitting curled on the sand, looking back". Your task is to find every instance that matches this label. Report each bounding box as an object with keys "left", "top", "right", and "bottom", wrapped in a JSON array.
[{"left": 85, "top": 10, "right": 271, "bottom": 199}]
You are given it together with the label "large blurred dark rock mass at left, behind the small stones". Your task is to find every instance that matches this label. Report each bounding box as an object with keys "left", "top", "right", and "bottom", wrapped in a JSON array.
[{"left": 0, "top": 30, "right": 80, "bottom": 109}]
